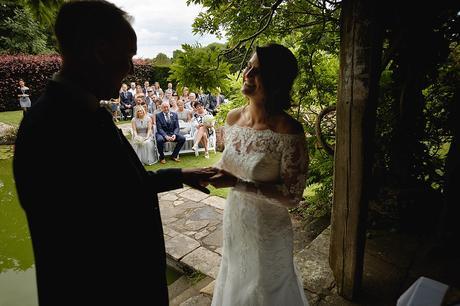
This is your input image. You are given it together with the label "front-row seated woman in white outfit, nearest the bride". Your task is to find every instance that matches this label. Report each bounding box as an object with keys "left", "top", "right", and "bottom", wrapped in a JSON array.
[{"left": 192, "top": 101, "right": 214, "bottom": 158}]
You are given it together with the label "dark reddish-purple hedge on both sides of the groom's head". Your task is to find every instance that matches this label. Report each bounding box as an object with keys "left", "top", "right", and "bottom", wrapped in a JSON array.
[{"left": 0, "top": 54, "right": 169, "bottom": 112}]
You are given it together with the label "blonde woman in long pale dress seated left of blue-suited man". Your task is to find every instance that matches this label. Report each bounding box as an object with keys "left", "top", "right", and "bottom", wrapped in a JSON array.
[{"left": 131, "top": 103, "right": 158, "bottom": 165}]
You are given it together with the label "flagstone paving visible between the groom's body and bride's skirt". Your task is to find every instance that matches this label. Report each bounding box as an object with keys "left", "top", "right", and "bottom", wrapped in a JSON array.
[{"left": 159, "top": 187, "right": 225, "bottom": 278}]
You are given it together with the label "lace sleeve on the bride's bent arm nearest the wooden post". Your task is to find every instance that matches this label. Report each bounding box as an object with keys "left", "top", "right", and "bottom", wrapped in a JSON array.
[{"left": 234, "top": 136, "right": 308, "bottom": 207}]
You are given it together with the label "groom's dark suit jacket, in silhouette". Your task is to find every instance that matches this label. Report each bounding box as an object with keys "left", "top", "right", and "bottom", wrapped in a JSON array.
[{"left": 14, "top": 81, "right": 182, "bottom": 306}]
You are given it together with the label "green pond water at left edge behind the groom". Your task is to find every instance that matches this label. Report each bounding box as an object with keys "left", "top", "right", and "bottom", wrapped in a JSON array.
[{"left": 0, "top": 151, "right": 180, "bottom": 306}]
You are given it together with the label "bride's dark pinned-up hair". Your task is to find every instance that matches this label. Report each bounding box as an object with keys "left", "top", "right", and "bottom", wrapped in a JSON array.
[{"left": 256, "top": 44, "right": 299, "bottom": 114}]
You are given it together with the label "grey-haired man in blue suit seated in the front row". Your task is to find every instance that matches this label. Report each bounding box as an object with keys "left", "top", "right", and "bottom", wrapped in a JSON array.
[{"left": 156, "top": 101, "right": 185, "bottom": 164}]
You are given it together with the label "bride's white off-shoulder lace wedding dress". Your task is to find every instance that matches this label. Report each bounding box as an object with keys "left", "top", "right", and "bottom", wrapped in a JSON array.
[{"left": 212, "top": 124, "right": 308, "bottom": 306}]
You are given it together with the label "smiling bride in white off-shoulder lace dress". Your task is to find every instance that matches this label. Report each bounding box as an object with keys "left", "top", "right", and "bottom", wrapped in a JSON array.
[{"left": 210, "top": 44, "right": 308, "bottom": 306}]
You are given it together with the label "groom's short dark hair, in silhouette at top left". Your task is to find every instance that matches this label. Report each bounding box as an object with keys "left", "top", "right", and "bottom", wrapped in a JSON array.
[{"left": 54, "top": 0, "right": 134, "bottom": 58}]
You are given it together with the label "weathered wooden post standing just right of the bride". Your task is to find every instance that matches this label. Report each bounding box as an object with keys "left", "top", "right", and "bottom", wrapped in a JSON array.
[{"left": 329, "top": 0, "right": 382, "bottom": 300}]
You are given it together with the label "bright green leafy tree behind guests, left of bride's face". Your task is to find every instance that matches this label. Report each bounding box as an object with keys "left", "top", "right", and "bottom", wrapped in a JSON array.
[{"left": 170, "top": 44, "right": 230, "bottom": 92}]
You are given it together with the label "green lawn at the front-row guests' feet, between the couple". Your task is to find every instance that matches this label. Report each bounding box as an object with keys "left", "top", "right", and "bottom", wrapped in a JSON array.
[{"left": 145, "top": 152, "right": 230, "bottom": 198}]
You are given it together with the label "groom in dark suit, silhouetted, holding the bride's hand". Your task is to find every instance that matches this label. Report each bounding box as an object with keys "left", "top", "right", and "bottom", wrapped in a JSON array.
[{"left": 13, "top": 1, "right": 216, "bottom": 306}]
